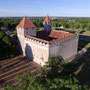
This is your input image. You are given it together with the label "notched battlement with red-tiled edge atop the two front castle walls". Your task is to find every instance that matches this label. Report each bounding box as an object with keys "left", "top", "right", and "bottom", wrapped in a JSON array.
[{"left": 25, "top": 35, "right": 78, "bottom": 47}]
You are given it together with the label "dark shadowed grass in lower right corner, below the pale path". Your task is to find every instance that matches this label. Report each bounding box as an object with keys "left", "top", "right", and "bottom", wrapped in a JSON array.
[{"left": 69, "top": 47, "right": 90, "bottom": 88}]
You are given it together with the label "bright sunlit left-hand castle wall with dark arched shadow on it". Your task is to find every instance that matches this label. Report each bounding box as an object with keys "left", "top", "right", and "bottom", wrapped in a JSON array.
[{"left": 18, "top": 35, "right": 49, "bottom": 66}]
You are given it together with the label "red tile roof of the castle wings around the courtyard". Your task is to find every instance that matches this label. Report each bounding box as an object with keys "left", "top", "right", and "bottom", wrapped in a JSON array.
[{"left": 27, "top": 31, "right": 75, "bottom": 44}]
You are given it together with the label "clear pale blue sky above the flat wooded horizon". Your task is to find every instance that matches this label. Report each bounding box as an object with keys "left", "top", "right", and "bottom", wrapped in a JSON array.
[{"left": 0, "top": 0, "right": 90, "bottom": 17}]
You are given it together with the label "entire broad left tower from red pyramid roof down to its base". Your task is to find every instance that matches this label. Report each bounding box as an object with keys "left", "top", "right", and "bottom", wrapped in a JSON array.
[{"left": 17, "top": 17, "right": 36, "bottom": 55}]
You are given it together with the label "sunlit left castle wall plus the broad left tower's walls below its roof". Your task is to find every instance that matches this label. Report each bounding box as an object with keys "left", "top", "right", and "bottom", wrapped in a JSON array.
[{"left": 17, "top": 28, "right": 49, "bottom": 66}]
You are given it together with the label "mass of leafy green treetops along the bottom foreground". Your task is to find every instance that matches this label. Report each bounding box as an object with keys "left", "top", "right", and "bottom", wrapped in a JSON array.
[{"left": 4, "top": 57, "right": 88, "bottom": 90}]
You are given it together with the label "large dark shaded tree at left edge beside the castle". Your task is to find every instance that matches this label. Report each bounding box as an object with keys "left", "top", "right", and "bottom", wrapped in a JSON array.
[{"left": 0, "top": 31, "right": 17, "bottom": 59}]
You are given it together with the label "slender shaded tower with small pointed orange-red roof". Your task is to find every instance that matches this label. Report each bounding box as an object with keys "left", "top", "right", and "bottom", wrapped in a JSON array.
[{"left": 43, "top": 16, "right": 52, "bottom": 37}]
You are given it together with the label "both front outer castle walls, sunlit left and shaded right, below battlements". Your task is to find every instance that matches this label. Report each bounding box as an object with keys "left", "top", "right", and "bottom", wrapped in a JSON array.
[{"left": 17, "top": 29, "right": 78, "bottom": 66}]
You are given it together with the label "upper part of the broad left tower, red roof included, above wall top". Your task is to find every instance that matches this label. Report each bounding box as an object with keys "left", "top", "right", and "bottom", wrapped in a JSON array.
[{"left": 17, "top": 17, "right": 36, "bottom": 37}]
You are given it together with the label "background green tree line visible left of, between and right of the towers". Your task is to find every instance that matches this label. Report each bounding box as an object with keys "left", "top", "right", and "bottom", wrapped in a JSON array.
[{"left": 0, "top": 17, "right": 90, "bottom": 30}]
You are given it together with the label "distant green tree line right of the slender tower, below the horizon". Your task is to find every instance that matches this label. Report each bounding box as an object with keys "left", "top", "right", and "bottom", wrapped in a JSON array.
[{"left": 52, "top": 18, "right": 90, "bottom": 30}]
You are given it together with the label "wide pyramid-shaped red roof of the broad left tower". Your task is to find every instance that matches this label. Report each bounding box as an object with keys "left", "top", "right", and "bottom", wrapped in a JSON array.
[{"left": 17, "top": 17, "right": 36, "bottom": 28}]
